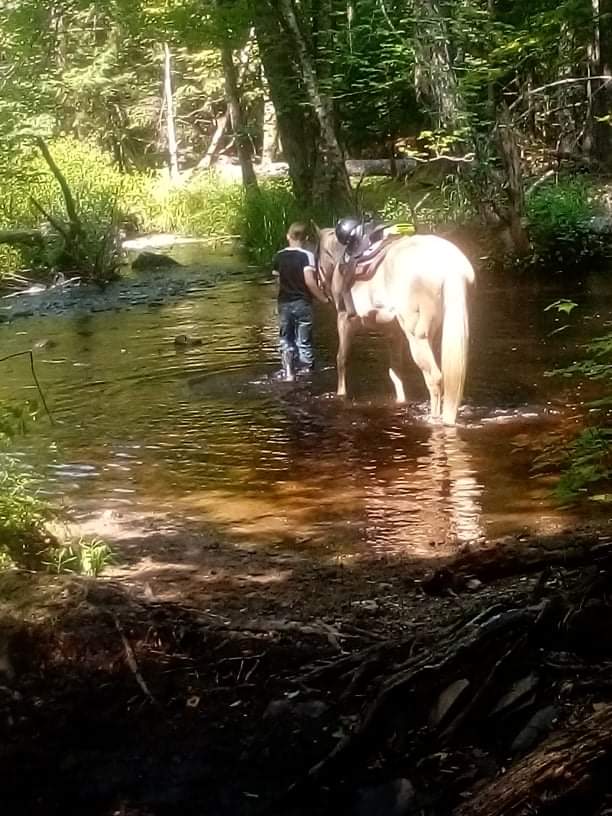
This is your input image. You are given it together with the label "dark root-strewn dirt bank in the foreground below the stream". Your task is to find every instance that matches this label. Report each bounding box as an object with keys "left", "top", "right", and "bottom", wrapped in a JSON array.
[{"left": 0, "top": 528, "right": 612, "bottom": 816}]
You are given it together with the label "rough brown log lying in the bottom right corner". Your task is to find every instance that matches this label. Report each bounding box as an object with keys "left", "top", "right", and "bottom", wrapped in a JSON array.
[{"left": 453, "top": 704, "right": 612, "bottom": 816}]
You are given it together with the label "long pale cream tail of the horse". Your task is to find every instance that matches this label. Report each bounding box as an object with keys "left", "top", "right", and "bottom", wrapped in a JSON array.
[{"left": 442, "top": 258, "right": 474, "bottom": 425}]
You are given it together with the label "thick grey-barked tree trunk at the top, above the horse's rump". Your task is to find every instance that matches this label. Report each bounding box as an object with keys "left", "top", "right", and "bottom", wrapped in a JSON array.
[{"left": 415, "top": 0, "right": 463, "bottom": 132}]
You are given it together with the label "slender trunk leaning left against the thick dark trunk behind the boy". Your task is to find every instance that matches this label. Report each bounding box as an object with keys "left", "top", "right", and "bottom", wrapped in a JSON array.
[{"left": 279, "top": 0, "right": 352, "bottom": 205}]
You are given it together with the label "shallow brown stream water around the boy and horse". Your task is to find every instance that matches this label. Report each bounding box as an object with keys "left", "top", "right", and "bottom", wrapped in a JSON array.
[{"left": 0, "top": 259, "right": 612, "bottom": 553}]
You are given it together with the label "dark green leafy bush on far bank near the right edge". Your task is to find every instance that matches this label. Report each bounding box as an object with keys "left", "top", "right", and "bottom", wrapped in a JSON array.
[{"left": 527, "top": 178, "right": 607, "bottom": 269}]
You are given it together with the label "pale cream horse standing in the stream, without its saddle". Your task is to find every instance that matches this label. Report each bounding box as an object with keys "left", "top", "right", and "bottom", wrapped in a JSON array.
[{"left": 319, "top": 229, "right": 475, "bottom": 425}]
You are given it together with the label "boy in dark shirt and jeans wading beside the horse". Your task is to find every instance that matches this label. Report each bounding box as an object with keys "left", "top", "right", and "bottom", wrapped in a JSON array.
[{"left": 272, "top": 222, "right": 327, "bottom": 380}]
